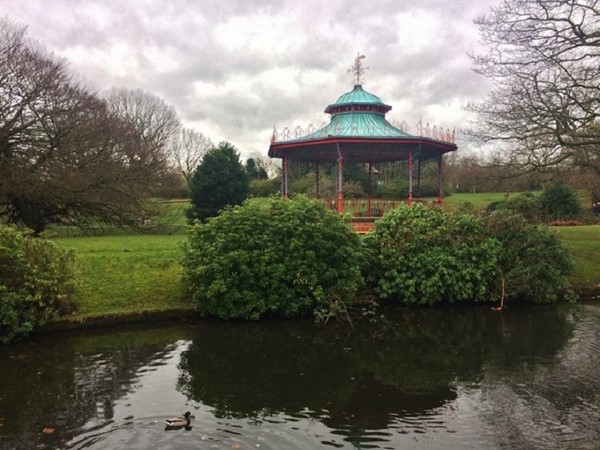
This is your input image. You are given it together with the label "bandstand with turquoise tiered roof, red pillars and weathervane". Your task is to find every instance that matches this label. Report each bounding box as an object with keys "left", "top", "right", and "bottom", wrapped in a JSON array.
[{"left": 269, "top": 56, "right": 458, "bottom": 231}]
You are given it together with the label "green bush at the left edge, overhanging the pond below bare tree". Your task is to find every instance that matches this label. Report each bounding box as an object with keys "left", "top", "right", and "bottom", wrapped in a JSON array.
[{"left": 0, "top": 225, "right": 75, "bottom": 342}]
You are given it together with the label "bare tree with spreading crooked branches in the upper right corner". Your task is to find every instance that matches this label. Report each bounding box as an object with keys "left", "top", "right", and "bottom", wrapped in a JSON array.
[{"left": 469, "top": 0, "right": 600, "bottom": 181}]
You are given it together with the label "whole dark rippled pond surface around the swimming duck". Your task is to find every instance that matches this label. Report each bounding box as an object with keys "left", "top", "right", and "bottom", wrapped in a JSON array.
[{"left": 0, "top": 304, "right": 600, "bottom": 450}]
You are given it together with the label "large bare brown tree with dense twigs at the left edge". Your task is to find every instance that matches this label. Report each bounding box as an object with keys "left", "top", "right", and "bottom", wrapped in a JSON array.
[{"left": 0, "top": 21, "right": 173, "bottom": 233}]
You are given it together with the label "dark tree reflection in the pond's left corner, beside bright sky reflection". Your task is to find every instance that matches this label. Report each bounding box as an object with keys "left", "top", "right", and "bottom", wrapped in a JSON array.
[{"left": 0, "top": 329, "right": 193, "bottom": 450}]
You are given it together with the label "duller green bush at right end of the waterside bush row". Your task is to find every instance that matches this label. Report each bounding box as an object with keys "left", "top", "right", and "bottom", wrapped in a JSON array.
[{"left": 485, "top": 211, "right": 573, "bottom": 303}]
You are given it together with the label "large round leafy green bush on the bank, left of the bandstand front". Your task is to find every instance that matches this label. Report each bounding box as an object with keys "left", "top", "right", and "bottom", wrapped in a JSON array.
[{"left": 183, "top": 196, "right": 362, "bottom": 319}]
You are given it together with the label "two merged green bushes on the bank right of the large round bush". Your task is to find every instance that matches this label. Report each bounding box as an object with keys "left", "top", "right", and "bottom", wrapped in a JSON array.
[{"left": 366, "top": 205, "right": 573, "bottom": 304}]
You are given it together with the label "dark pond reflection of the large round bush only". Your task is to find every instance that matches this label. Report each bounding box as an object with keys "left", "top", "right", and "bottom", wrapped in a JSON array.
[{"left": 179, "top": 322, "right": 358, "bottom": 417}]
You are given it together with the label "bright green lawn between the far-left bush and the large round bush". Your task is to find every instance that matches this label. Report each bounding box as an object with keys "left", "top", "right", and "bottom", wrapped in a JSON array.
[{"left": 57, "top": 235, "right": 192, "bottom": 320}]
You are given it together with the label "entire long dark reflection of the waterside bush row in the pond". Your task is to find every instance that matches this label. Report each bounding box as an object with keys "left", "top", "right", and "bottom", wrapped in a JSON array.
[{"left": 178, "top": 308, "right": 571, "bottom": 427}]
